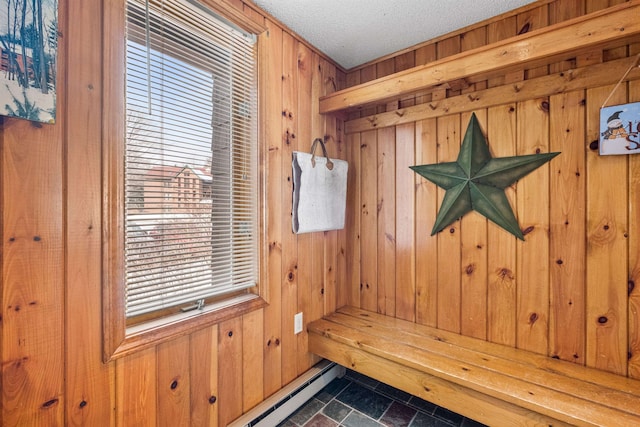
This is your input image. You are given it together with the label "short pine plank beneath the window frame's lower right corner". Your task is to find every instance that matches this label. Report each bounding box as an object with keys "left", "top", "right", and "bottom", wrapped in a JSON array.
[{"left": 242, "top": 309, "right": 266, "bottom": 413}]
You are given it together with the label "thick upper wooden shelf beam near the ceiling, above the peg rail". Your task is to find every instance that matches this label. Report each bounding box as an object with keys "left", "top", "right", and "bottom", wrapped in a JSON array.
[{"left": 320, "top": 0, "right": 640, "bottom": 114}]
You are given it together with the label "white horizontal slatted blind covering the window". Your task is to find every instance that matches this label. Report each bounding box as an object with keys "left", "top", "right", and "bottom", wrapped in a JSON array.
[{"left": 124, "top": 0, "right": 258, "bottom": 317}]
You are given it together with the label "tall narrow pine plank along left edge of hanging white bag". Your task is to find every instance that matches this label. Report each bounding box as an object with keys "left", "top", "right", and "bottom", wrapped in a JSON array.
[{"left": 281, "top": 33, "right": 298, "bottom": 384}]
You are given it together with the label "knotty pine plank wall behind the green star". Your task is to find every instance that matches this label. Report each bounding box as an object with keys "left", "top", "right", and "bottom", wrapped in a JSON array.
[{"left": 345, "top": 0, "right": 640, "bottom": 378}]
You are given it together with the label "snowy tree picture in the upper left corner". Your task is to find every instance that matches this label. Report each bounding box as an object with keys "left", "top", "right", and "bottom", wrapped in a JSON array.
[{"left": 0, "top": 0, "right": 58, "bottom": 123}]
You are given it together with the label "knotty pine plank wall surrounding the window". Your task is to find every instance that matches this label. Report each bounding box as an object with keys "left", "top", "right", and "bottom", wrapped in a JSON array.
[{"left": 0, "top": 0, "right": 348, "bottom": 427}]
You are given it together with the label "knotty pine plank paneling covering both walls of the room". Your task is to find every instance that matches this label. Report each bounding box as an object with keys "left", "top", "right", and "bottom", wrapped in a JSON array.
[{"left": 0, "top": 0, "right": 640, "bottom": 426}]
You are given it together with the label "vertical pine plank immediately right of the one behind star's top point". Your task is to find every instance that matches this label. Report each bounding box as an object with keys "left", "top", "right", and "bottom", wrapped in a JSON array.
[{"left": 486, "top": 104, "right": 517, "bottom": 347}]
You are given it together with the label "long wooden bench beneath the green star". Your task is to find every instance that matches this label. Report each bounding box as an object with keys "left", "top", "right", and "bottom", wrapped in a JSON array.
[{"left": 307, "top": 307, "right": 640, "bottom": 427}]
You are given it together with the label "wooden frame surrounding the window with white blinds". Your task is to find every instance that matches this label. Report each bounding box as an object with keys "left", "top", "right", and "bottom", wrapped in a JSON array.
[{"left": 102, "top": 0, "right": 268, "bottom": 363}]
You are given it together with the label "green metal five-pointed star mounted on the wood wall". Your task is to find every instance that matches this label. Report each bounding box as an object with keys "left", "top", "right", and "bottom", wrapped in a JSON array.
[{"left": 410, "top": 114, "right": 560, "bottom": 240}]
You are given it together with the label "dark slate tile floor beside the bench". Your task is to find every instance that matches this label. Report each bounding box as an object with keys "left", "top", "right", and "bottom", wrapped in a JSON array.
[{"left": 279, "top": 370, "right": 482, "bottom": 427}]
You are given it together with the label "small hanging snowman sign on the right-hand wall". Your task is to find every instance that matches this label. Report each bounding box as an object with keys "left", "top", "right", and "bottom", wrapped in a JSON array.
[{"left": 599, "top": 102, "right": 640, "bottom": 155}]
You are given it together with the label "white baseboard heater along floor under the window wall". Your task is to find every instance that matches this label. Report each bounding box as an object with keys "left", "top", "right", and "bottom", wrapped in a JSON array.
[{"left": 229, "top": 360, "right": 345, "bottom": 427}]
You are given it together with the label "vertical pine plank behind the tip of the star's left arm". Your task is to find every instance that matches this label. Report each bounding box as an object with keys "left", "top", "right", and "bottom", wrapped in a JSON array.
[{"left": 415, "top": 119, "right": 439, "bottom": 326}]
